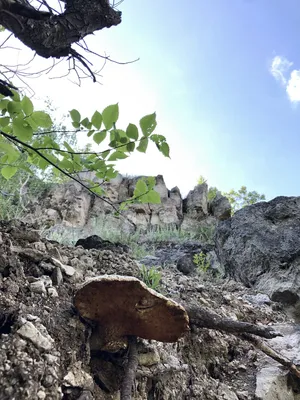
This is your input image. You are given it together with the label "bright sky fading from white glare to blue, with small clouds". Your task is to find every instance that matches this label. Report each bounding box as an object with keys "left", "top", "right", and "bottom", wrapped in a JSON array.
[{"left": 2, "top": 0, "right": 300, "bottom": 199}]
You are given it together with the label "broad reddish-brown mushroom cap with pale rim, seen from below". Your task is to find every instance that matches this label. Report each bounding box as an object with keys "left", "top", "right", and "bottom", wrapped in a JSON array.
[{"left": 74, "top": 275, "right": 189, "bottom": 342}]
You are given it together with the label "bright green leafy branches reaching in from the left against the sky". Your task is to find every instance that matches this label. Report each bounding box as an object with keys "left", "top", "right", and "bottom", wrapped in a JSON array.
[{"left": 0, "top": 90, "right": 169, "bottom": 218}]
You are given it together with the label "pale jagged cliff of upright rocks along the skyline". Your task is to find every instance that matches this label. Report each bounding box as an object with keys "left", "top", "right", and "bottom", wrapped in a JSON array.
[{"left": 27, "top": 175, "right": 231, "bottom": 232}]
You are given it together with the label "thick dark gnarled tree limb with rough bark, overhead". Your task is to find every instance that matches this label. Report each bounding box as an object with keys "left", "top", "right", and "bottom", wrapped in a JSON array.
[{"left": 0, "top": 0, "right": 121, "bottom": 58}]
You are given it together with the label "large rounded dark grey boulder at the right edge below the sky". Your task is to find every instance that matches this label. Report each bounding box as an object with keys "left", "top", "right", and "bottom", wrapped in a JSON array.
[{"left": 216, "top": 197, "right": 300, "bottom": 305}]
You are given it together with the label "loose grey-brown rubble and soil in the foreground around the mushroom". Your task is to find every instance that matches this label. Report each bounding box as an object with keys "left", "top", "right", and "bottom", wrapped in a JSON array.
[{"left": 0, "top": 217, "right": 300, "bottom": 400}]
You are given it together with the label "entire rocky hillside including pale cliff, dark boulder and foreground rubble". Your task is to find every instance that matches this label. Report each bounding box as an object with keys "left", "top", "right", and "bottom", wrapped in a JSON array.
[{"left": 0, "top": 176, "right": 300, "bottom": 400}]
